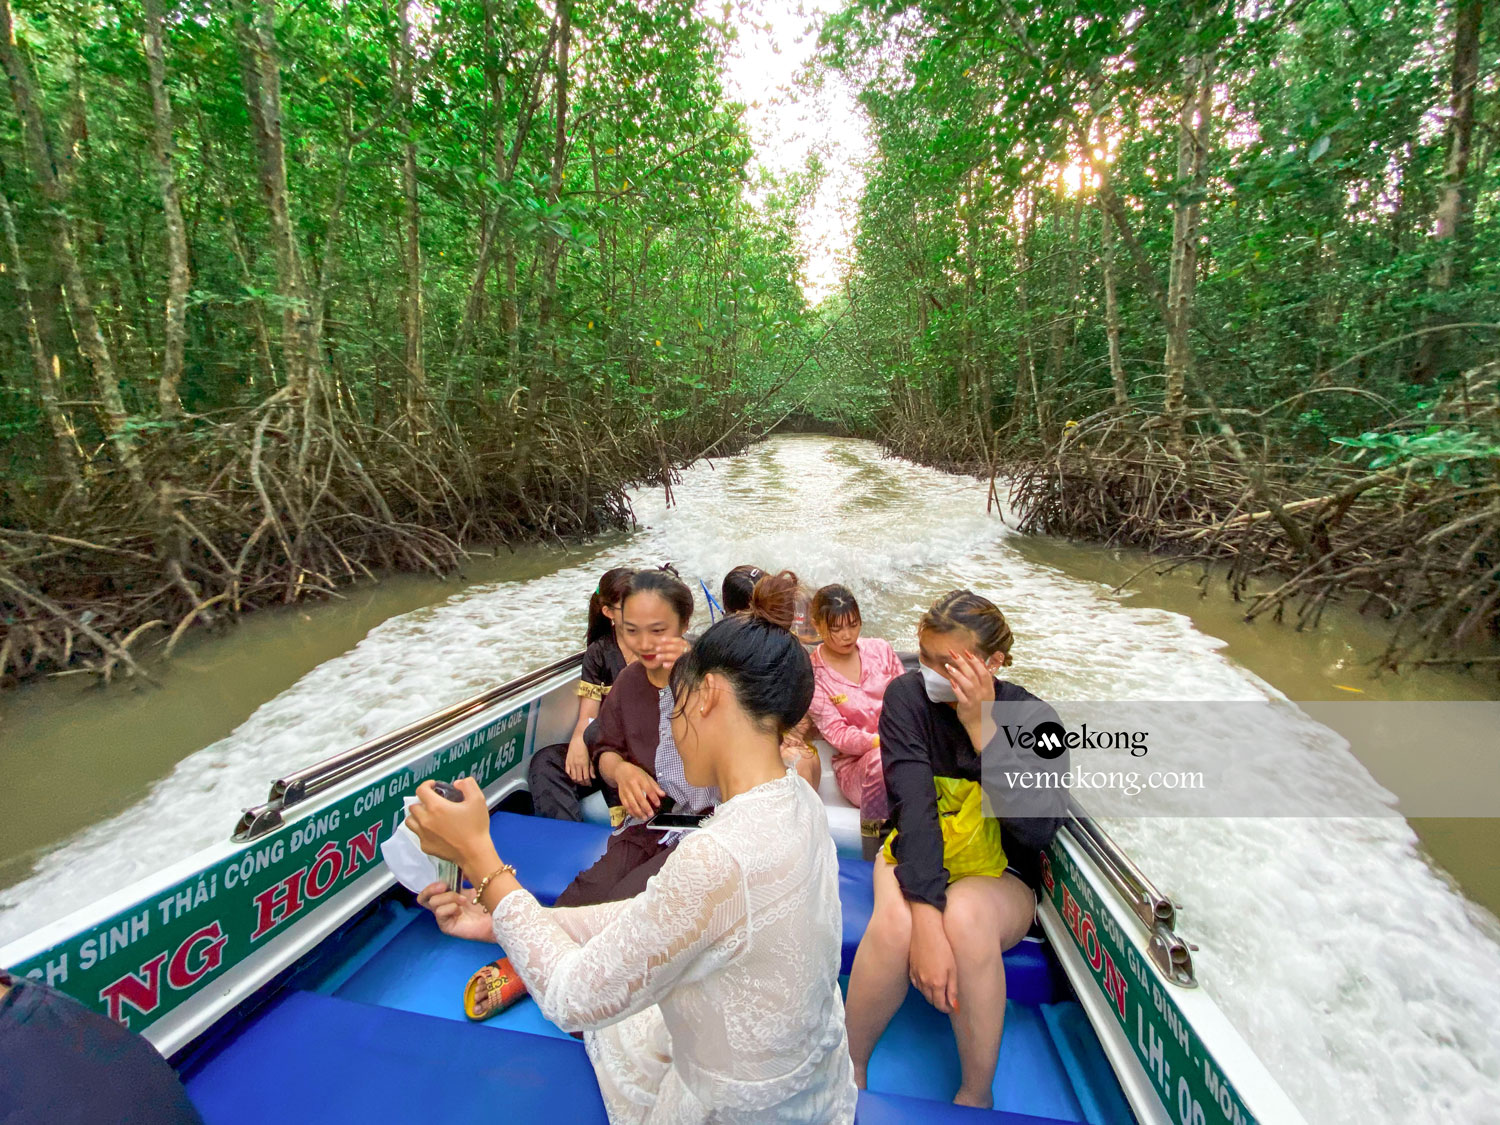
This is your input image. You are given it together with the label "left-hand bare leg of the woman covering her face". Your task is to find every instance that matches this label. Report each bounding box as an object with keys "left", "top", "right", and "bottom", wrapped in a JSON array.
[{"left": 845, "top": 855, "right": 912, "bottom": 1089}]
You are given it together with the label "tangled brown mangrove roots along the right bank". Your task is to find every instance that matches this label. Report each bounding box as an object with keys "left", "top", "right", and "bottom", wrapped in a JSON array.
[{"left": 881, "top": 393, "right": 1500, "bottom": 684}]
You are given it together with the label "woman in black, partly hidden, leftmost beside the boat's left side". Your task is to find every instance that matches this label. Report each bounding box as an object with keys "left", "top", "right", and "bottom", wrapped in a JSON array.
[{"left": 527, "top": 567, "right": 636, "bottom": 821}]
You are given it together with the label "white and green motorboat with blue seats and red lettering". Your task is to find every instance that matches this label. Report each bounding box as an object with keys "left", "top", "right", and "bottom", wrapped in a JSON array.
[{"left": 0, "top": 654, "right": 1302, "bottom": 1125}]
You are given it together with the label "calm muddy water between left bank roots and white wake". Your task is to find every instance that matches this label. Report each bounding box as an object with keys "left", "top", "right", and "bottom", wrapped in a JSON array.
[{"left": 0, "top": 537, "right": 618, "bottom": 887}]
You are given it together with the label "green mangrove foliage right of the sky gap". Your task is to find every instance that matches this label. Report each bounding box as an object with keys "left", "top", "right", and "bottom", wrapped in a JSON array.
[{"left": 822, "top": 0, "right": 1500, "bottom": 464}]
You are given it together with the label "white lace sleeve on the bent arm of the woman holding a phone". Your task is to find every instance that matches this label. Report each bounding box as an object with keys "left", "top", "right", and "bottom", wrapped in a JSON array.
[{"left": 494, "top": 833, "right": 749, "bottom": 1031}]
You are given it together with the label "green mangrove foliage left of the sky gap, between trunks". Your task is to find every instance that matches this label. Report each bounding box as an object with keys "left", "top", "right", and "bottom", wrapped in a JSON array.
[{"left": 0, "top": 0, "right": 810, "bottom": 492}]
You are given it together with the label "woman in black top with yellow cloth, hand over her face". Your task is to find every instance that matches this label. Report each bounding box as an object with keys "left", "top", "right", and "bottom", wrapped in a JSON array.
[{"left": 846, "top": 590, "right": 1059, "bottom": 1107}]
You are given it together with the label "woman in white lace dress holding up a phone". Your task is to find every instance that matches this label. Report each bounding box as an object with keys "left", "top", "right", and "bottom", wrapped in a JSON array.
[{"left": 410, "top": 573, "right": 857, "bottom": 1124}]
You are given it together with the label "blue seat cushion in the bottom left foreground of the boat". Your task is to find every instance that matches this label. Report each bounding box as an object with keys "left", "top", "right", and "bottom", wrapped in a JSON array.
[{"left": 185, "top": 992, "right": 608, "bottom": 1125}]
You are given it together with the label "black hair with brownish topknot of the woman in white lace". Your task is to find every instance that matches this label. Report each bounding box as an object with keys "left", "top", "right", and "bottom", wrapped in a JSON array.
[{"left": 672, "top": 570, "right": 813, "bottom": 738}]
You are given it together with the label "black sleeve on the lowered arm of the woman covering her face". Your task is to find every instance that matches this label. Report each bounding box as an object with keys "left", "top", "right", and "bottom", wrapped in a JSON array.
[{"left": 881, "top": 672, "right": 948, "bottom": 911}]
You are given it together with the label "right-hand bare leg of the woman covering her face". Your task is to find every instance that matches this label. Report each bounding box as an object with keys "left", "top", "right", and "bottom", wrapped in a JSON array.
[{"left": 942, "top": 873, "right": 1037, "bottom": 1109}]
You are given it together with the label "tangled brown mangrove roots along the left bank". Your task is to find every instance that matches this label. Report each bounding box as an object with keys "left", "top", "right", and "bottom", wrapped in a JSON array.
[{"left": 0, "top": 414, "right": 756, "bottom": 689}]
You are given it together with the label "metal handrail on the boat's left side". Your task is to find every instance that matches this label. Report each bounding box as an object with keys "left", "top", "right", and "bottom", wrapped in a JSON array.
[{"left": 234, "top": 651, "right": 584, "bottom": 840}]
